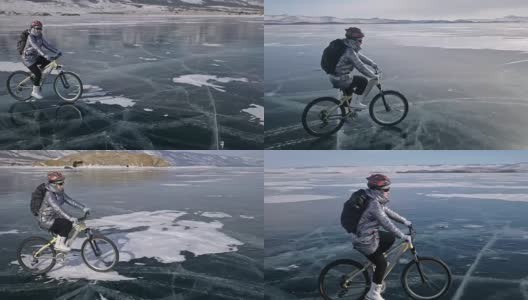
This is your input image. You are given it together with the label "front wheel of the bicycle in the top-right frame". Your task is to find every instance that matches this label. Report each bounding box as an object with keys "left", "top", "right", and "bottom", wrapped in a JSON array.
[{"left": 369, "top": 91, "right": 409, "bottom": 126}]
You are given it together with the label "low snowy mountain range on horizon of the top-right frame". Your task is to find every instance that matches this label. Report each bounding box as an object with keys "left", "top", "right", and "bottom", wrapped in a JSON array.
[{"left": 264, "top": 15, "right": 528, "bottom": 25}]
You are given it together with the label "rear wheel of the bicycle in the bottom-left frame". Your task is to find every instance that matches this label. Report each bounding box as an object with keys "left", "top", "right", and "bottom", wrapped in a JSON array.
[{"left": 17, "top": 236, "right": 56, "bottom": 274}]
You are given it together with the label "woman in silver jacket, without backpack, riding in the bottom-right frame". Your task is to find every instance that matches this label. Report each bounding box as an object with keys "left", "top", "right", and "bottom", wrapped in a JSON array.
[{"left": 351, "top": 174, "right": 412, "bottom": 300}]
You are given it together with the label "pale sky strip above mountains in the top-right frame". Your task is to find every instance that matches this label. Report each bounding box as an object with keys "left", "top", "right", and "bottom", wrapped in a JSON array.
[{"left": 265, "top": 0, "right": 528, "bottom": 20}]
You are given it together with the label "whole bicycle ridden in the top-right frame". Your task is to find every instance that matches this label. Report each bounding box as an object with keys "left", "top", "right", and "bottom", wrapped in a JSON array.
[{"left": 301, "top": 71, "right": 409, "bottom": 137}]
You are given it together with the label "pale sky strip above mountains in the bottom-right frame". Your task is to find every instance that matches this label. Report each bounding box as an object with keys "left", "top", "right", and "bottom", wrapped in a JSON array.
[{"left": 264, "top": 150, "right": 528, "bottom": 168}]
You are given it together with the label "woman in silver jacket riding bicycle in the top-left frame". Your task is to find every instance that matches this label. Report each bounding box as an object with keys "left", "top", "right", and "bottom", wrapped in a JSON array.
[{"left": 22, "top": 20, "right": 62, "bottom": 100}]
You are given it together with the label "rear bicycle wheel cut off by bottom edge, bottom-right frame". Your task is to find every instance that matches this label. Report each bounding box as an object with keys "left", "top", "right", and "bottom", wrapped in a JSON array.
[{"left": 319, "top": 259, "right": 370, "bottom": 300}]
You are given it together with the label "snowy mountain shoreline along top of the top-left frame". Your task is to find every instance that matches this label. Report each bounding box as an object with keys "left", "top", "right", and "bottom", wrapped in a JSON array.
[{"left": 0, "top": 0, "right": 264, "bottom": 15}]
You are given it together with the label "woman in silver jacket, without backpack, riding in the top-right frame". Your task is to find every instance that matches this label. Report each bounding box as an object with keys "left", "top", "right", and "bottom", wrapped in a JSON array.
[{"left": 329, "top": 27, "right": 378, "bottom": 109}]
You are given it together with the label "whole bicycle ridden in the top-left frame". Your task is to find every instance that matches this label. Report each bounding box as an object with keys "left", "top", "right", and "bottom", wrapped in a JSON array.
[{"left": 7, "top": 55, "right": 83, "bottom": 102}]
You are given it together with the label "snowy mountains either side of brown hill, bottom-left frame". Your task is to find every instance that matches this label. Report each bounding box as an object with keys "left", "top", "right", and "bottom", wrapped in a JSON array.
[{"left": 0, "top": 150, "right": 263, "bottom": 167}]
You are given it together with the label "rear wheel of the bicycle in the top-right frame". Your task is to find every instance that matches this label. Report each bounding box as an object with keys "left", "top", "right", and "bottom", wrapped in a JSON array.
[{"left": 302, "top": 97, "right": 346, "bottom": 137}]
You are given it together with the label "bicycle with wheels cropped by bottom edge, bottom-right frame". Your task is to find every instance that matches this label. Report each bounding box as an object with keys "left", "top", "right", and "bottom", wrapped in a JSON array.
[{"left": 319, "top": 228, "right": 452, "bottom": 300}]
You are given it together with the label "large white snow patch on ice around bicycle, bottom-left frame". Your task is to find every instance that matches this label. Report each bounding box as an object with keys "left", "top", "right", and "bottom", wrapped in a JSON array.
[{"left": 41, "top": 210, "right": 243, "bottom": 281}]
